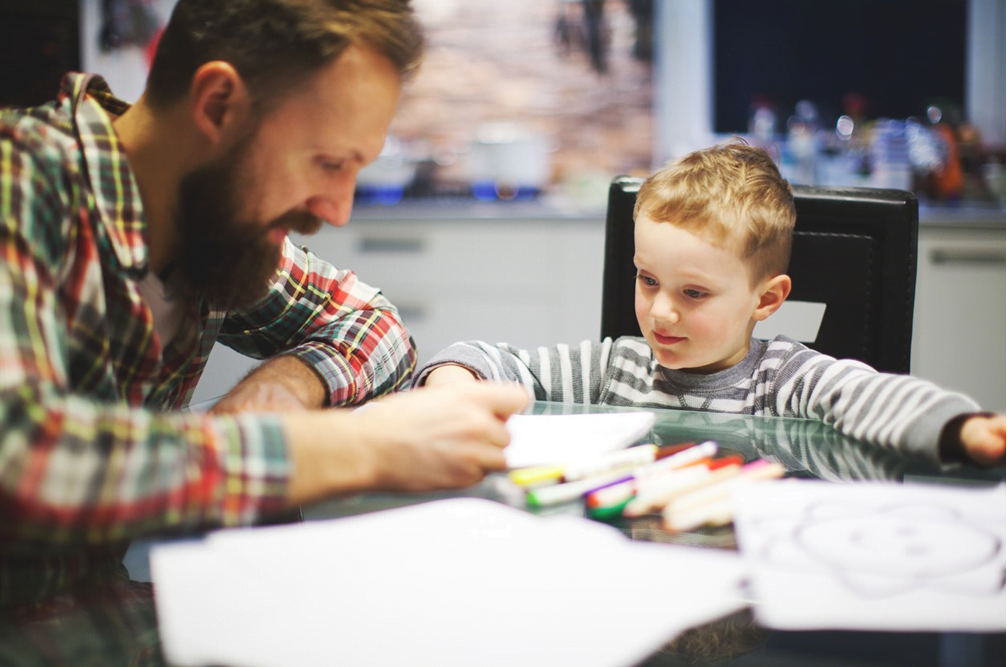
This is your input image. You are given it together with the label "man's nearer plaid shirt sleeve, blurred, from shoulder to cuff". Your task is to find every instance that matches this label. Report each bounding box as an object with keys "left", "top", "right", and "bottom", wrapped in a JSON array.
[{"left": 0, "top": 123, "right": 290, "bottom": 552}]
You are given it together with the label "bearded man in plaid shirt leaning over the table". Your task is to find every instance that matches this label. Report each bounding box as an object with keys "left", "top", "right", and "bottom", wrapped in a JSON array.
[{"left": 0, "top": 0, "right": 528, "bottom": 580}]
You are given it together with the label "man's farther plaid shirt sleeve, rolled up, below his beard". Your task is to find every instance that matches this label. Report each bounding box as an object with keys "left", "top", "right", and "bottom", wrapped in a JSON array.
[{"left": 219, "top": 239, "right": 416, "bottom": 406}]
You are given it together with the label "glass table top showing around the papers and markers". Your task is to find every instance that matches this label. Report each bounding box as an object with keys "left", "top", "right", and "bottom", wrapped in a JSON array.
[{"left": 0, "top": 403, "right": 1005, "bottom": 667}]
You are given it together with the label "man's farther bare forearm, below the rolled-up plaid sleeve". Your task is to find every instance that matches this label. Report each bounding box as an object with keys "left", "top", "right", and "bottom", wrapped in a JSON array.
[{"left": 209, "top": 357, "right": 325, "bottom": 414}]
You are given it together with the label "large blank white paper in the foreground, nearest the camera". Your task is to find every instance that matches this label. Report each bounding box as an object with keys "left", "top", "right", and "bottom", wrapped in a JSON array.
[{"left": 151, "top": 499, "right": 744, "bottom": 667}]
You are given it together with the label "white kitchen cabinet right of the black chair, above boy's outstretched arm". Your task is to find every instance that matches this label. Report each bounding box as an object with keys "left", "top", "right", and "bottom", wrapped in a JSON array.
[{"left": 910, "top": 224, "right": 1007, "bottom": 411}]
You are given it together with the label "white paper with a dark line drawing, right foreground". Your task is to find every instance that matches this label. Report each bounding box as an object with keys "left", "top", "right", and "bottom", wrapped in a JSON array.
[{"left": 733, "top": 481, "right": 1007, "bottom": 632}]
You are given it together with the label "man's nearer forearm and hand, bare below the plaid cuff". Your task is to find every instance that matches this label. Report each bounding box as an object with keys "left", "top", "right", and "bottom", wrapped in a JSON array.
[{"left": 285, "top": 382, "right": 529, "bottom": 504}]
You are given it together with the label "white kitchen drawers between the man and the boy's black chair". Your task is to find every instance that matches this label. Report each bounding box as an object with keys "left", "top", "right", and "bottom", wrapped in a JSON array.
[{"left": 193, "top": 216, "right": 608, "bottom": 403}]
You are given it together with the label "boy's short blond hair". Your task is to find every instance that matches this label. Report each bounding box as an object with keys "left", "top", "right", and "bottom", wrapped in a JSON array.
[{"left": 633, "top": 140, "right": 797, "bottom": 284}]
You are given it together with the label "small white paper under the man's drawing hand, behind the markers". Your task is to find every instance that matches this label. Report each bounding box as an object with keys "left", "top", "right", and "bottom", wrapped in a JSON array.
[{"left": 504, "top": 412, "right": 655, "bottom": 469}]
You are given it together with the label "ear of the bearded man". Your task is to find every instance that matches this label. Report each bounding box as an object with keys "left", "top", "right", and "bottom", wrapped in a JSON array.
[{"left": 189, "top": 60, "right": 252, "bottom": 145}]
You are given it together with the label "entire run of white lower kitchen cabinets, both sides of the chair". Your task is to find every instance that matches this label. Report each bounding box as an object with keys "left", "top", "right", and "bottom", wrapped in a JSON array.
[{"left": 193, "top": 211, "right": 1007, "bottom": 410}]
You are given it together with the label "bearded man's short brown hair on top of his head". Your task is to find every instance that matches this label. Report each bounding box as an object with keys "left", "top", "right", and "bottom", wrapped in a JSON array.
[{"left": 146, "top": 0, "right": 423, "bottom": 110}]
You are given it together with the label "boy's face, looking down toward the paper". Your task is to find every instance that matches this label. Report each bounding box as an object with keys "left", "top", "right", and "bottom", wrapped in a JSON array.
[{"left": 633, "top": 215, "right": 768, "bottom": 373}]
